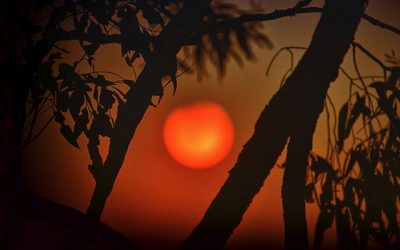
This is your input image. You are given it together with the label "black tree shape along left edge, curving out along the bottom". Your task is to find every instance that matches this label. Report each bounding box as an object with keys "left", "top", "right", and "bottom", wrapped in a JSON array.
[{"left": 0, "top": 1, "right": 138, "bottom": 249}]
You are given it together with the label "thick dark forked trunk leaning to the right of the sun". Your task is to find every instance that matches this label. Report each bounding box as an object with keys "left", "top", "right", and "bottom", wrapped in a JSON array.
[{"left": 182, "top": 0, "right": 366, "bottom": 249}]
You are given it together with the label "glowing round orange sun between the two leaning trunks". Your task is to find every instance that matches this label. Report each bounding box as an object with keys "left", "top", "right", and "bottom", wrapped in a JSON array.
[{"left": 163, "top": 102, "right": 233, "bottom": 169}]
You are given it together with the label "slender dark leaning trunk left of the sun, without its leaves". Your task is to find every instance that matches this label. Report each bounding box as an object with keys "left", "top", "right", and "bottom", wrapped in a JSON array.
[{"left": 87, "top": 0, "right": 211, "bottom": 219}]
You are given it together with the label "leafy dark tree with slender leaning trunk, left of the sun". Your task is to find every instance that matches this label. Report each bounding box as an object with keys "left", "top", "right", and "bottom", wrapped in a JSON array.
[{"left": 32, "top": 1, "right": 271, "bottom": 218}]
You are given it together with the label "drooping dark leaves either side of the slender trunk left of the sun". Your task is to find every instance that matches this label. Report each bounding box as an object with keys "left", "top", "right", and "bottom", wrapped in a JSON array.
[{"left": 19, "top": 0, "right": 272, "bottom": 155}]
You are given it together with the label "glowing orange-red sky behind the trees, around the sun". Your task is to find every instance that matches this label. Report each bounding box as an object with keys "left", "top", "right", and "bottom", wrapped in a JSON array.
[{"left": 23, "top": 0, "right": 400, "bottom": 249}]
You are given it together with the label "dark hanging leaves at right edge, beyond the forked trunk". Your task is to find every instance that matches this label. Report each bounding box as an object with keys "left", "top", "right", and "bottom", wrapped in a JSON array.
[{"left": 305, "top": 49, "right": 400, "bottom": 249}]
